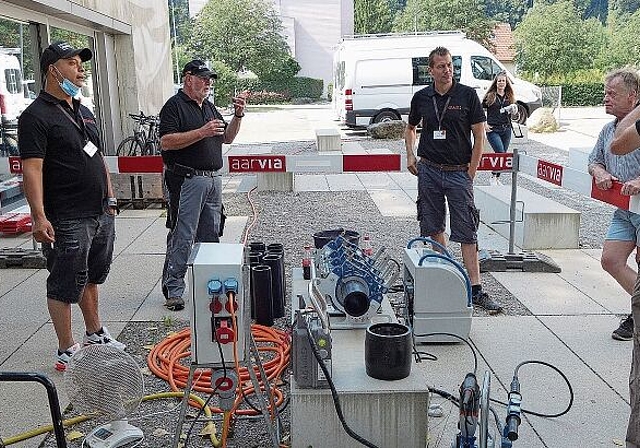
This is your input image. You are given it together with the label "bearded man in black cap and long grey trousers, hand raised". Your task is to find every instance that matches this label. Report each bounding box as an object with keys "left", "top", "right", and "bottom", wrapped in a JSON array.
[{"left": 159, "top": 59, "right": 246, "bottom": 311}]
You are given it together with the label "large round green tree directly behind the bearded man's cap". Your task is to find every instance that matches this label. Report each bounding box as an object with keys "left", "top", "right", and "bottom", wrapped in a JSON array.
[{"left": 189, "top": 0, "right": 291, "bottom": 77}]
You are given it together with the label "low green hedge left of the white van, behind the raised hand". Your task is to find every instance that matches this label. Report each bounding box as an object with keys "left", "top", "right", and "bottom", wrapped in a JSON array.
[{"left": 237, "top": 76, "right": 324, "bottom": 104}]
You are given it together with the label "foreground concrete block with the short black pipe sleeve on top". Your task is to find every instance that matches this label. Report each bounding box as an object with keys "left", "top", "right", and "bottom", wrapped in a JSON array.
[{"left": 290, "top": 330, "right": 429, "bottom": 448}]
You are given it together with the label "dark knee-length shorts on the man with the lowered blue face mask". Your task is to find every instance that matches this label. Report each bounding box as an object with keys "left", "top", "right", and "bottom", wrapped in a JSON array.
[{"left": 42, "top": 213, "right": 115, "bottom": 303}]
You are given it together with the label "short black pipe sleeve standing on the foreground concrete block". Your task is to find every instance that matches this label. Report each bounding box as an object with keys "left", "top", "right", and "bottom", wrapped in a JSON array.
[{"left": 364, "top": 322, "right": 412, "bottom": 380}]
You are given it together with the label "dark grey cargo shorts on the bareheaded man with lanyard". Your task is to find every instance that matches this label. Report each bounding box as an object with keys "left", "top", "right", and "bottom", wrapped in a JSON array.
[{"left": 417, "top": 162, "right": 480, "bottom": 244}]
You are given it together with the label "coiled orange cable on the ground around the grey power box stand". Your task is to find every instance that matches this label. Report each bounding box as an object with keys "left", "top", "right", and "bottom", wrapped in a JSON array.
[{"left": 147, "top": 324, "right": 291, "bottom": 416}]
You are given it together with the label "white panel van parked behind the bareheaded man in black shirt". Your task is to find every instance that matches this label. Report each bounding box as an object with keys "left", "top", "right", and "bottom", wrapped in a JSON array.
[{"left": 332, "top": 31, "right": 542, "bottom": 127}]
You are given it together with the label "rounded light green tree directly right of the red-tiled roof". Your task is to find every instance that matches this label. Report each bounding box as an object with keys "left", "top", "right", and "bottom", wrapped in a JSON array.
[{"left": 515, "top": 0, "right": 605, "bottom": 82}]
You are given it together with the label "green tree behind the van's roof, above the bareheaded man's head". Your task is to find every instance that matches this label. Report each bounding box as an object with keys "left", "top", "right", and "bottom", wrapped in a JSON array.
[{"left": 393, "top": 0, "right": 494, "bottom": 43}]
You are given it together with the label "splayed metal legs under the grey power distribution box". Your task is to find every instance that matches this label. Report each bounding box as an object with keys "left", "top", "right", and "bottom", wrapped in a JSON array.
[{"left": 172, "top": 332, "right": 280, "bottom": 448}]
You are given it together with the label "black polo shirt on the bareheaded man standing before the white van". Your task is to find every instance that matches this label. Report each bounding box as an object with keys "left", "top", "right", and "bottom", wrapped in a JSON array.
[{"left": 409, "top": 81, "right": 486, "bottom": 165}]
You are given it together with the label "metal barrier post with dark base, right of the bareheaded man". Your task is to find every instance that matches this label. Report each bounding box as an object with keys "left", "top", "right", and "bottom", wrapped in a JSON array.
[{"left": 478, "top": 146, "right": 562, "bottom": 274}]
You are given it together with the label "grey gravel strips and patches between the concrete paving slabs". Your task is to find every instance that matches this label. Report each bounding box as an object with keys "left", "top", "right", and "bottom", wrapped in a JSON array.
[{"left": 44, "top": 134, "right": 613, "bottom": 447}]
